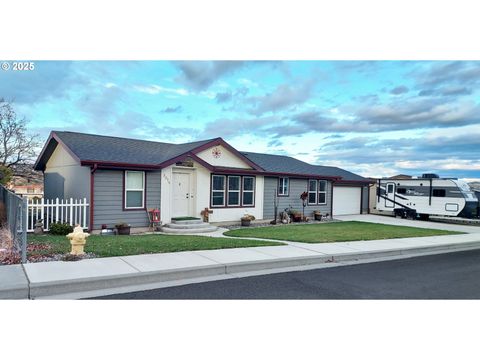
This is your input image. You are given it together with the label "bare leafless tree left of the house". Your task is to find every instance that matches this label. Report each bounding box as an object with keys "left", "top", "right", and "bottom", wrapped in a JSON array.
[{"left": 0, "top": 98, "right": 40, "bottom": 171}]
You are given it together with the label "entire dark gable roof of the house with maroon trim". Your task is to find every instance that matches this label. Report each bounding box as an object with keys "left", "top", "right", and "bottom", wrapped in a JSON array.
[{"left": 34, "top": 131, "right": 369, "bottom": 183}]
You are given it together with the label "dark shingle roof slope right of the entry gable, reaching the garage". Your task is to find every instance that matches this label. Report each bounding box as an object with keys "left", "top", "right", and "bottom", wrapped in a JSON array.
[{"left": 241, "top": 151, "right": 368, "bottom": 181}]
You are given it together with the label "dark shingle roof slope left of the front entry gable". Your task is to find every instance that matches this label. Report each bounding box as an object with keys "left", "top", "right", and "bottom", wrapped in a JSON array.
[{"left": 43, "top": 131, "right": 216, "bottom": 165}]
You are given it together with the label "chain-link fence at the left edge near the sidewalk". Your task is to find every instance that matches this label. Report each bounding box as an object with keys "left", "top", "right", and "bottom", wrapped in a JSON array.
[{"left": 0, "top": 185, "right": 27, "bottom": 263}]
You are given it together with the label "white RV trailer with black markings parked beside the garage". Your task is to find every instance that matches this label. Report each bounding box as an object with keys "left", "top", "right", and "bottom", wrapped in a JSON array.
[{"left": 376, "top": 174, "right": 479, "bottom": 220}]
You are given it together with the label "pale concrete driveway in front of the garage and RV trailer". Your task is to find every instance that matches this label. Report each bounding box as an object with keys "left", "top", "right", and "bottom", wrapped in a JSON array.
[{"left": 334, "top": 214, "right": 480, "bottom": 234}]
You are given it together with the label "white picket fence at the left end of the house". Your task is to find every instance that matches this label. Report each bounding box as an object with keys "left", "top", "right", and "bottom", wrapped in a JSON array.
[{"left": 27, "top": 198, "right": 90, "bottom": 232}]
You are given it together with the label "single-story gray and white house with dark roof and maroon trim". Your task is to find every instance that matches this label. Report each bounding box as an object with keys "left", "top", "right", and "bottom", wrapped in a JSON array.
[{"left": 35, "top": 131, "right": 369, "bottom": 230}]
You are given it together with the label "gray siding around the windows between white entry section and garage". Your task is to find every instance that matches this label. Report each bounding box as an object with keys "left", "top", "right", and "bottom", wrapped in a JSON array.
[{"left": 263, "top": 177, "right": 332, "bottom": 219}]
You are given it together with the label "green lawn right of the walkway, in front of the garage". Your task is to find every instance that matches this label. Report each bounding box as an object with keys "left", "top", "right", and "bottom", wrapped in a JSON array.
[{"left": 224, "top": 221, "right": 463, "bottom": 243}]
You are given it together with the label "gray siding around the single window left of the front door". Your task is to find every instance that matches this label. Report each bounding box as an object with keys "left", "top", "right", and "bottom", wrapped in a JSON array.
[{"left": 93, "top": 170, "right": 161, "bottom": 229}]
